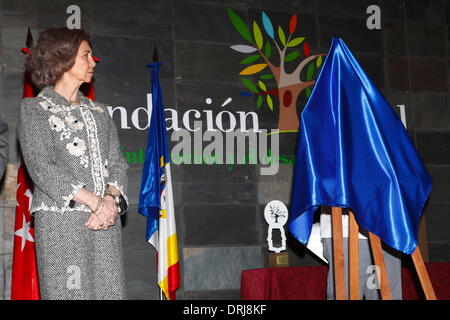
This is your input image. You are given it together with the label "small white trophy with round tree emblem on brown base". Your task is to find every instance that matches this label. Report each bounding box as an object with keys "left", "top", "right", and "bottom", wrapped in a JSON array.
[{"left": 264, "top": 200, "right": 289, "bottom": 267}]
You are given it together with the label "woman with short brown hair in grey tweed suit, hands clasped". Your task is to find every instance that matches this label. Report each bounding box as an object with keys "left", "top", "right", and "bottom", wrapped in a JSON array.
[{"left": 19, "top": 28, "right": 128, "bottom": 299}]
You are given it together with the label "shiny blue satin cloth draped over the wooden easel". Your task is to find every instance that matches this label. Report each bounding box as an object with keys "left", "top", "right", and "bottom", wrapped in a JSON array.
[{"left": 288, "top": 38, "right": 431, "bottom": 254}]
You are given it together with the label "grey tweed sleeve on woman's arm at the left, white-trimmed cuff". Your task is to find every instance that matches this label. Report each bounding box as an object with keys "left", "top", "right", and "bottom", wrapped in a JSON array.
[{"left": 18, "top": 98, "right": 84, "bottom": 213}]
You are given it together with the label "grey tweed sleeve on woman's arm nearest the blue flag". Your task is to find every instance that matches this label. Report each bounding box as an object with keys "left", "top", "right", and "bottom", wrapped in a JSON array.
[{"left": 107, "top": 116, "right": 129, "bottom": 214}]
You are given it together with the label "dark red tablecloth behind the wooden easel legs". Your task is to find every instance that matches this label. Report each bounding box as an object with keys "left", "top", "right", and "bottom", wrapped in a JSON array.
[{"left": 241, "top": 262, "right": 450, "bottom": 300}]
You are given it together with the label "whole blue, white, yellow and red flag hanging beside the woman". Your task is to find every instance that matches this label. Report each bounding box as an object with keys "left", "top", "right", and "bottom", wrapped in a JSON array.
[{"left": 139, "top": 63, "right": 180, "bottom": 300}]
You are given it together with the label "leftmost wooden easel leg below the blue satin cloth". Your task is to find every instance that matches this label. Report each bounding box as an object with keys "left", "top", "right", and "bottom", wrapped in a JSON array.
[{"left": 331, "top": 207, "right": 347, "bottom": 300}]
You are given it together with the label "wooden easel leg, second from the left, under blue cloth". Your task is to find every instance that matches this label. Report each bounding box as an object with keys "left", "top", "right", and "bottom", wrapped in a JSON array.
[{"left": 348, "top": 211, "right": 359, "bottom": 300}]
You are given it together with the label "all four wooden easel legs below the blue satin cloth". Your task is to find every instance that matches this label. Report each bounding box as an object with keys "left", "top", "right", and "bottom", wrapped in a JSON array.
[{"left": 331, "top": 207, "right": 436, "bottom": 300}]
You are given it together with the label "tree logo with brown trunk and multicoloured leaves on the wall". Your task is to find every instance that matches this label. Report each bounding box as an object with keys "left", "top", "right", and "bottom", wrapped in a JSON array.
[{"left": 228, "top": 9, "right": 325, "bottom": 131}]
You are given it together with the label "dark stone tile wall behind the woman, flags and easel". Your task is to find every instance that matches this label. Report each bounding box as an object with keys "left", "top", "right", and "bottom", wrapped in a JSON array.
[{"left": 0, "top": 0, "right": 450, "bottom": 299}]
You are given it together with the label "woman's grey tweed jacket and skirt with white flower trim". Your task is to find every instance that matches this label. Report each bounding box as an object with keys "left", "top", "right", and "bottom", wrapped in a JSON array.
[{"left": 18, "top": 86, "right": 128, "bottom": 299}]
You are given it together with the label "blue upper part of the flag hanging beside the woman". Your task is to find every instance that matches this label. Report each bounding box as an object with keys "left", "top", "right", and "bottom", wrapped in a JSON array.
[{"left": 139, "top": 63, "right": 170, "bottom": 241}]
